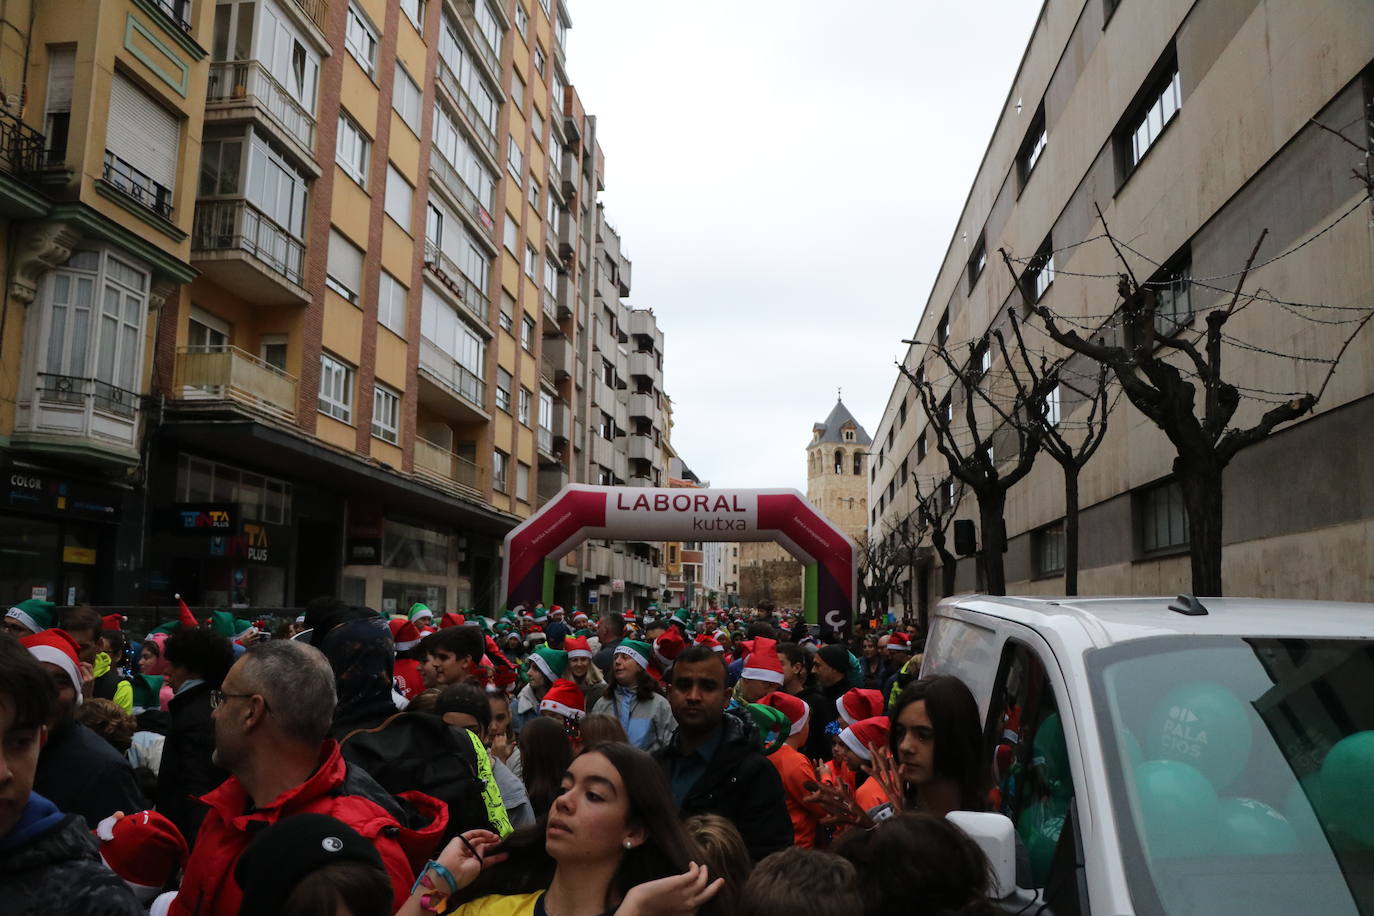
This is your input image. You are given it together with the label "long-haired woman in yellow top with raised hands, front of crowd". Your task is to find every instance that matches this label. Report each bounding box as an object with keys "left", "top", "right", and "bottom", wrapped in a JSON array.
[{"left": 398, "top": 744, "right": 724, "bottom": 916}]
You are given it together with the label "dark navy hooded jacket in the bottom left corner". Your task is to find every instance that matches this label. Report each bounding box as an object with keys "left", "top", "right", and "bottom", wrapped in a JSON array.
[{"left": 0, "top": 792, "right": 144, "bottom": 916}]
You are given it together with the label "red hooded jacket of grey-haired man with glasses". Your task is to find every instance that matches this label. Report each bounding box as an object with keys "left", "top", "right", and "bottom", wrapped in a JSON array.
[{"left": 170, "top": 740, "right": 448, "bottom": 916}]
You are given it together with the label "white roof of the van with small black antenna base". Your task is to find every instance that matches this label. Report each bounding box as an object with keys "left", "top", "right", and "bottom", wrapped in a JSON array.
[{"left": 945, "top": 595, "right": 1374, "bottom": 647}]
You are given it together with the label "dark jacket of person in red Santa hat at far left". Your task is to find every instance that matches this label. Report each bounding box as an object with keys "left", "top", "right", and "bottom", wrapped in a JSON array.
[{"left": 33, "top": 721, "right": 148, "bottom": 829}]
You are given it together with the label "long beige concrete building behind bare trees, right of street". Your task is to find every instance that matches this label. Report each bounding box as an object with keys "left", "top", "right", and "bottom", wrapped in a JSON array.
[{"left": 868, "top": 0, "right": 1374, "bottom": 615}]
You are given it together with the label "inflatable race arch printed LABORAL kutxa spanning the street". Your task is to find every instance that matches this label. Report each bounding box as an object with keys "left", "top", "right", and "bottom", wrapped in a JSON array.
[{"left": 502, "top": 483, "right": 859, "bottom": 634}]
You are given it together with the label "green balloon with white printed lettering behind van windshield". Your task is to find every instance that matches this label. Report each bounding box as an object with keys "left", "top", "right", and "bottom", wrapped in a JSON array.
[{"left": 1145, "top": 681, "right": 1253, "bottom": 790}]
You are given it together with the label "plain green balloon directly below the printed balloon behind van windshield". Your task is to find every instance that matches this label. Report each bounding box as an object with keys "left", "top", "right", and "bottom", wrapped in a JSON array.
[{"left": 1135, "top": 761, "right": 1217, "bottom": 858}]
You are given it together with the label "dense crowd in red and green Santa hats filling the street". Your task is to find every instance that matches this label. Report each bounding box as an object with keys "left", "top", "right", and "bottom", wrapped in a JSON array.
[{"left": 0, "top": 600, "right": 1011, "bottom": 916}]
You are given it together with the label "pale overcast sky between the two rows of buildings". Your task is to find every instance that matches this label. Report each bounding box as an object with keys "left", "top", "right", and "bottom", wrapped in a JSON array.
[{"left": 567, "top": 0, "right": 1041, "bottom": 490}]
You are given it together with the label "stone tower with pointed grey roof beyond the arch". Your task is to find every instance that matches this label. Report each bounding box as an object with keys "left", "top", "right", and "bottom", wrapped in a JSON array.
[{"left": 807, "top": 400, "right": 872, "bottom": 541}]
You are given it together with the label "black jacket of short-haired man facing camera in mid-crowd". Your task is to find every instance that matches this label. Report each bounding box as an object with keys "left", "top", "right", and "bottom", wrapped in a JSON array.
[{"left": 655, "top": 713, "right": 793, "bottom": 862}]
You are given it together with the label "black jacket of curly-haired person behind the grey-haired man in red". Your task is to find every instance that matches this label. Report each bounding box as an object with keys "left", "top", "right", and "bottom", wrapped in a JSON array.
[{"left": 157, "top": 683, "right": 229, "bottom": 846}]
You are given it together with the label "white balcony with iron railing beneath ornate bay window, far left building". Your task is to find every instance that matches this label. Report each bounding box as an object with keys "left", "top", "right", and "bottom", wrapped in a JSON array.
[{"left": 11, "top": 372, "right": 143, "bottom": 464}]
